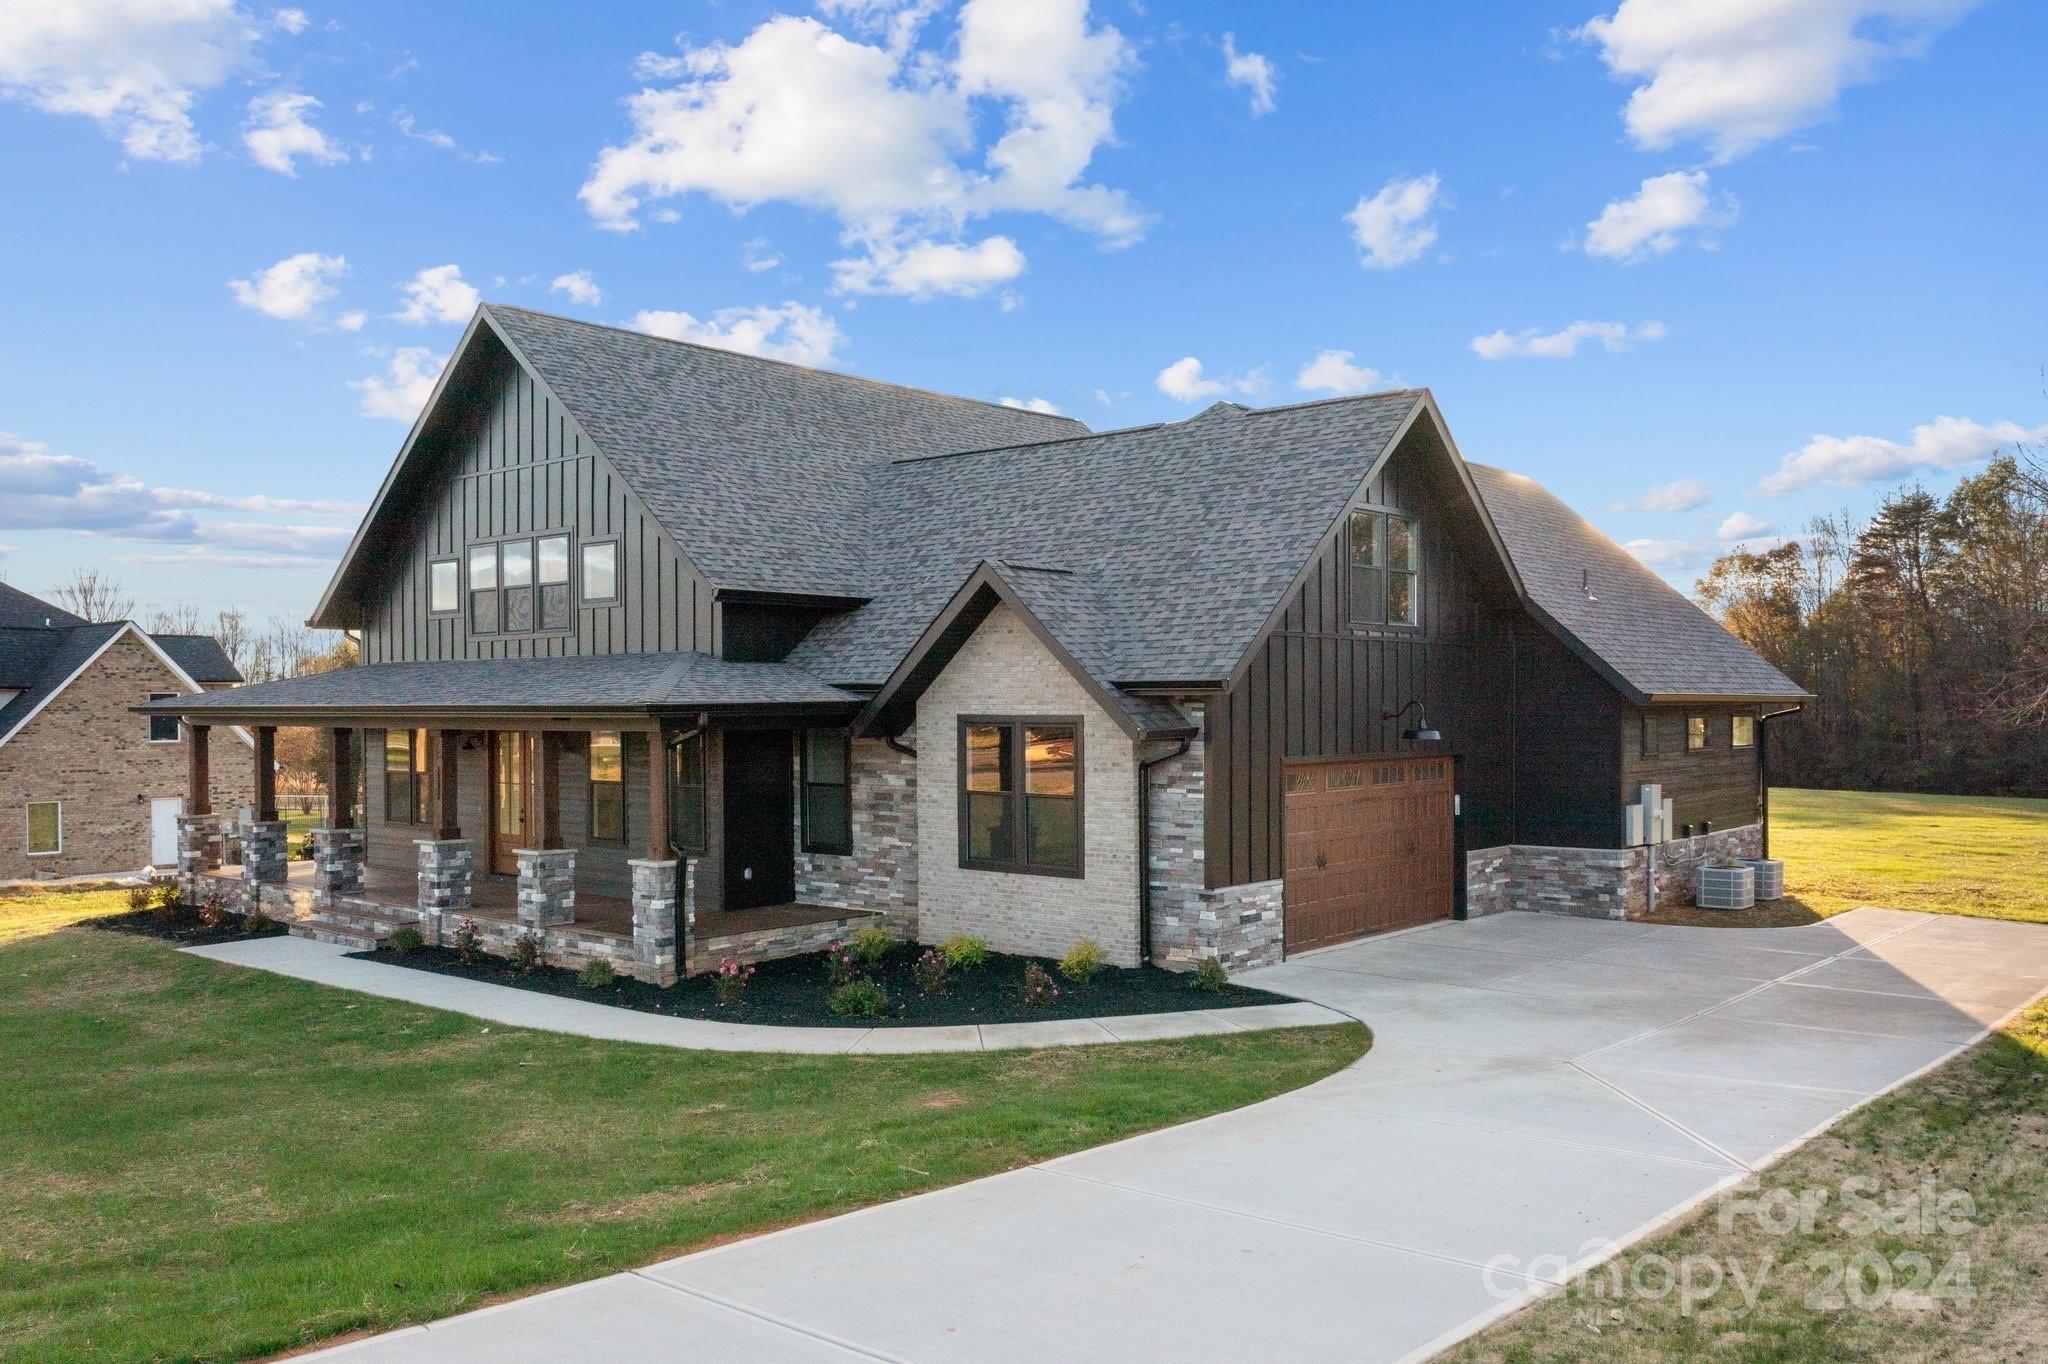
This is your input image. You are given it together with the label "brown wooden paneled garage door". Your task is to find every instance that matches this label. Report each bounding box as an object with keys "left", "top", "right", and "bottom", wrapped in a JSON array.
[{"left": 1284, "top": 758, "right": 1452, "bottom": 952}]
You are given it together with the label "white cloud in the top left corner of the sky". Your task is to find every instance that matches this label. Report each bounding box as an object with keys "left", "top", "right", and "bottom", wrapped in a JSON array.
[{"left": 0, "top": 0, "right": 258, "bottom": 162}]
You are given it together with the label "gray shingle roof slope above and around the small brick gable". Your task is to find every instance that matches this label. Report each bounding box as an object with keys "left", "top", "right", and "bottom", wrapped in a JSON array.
[{"left": 788, "top": 391, "right": 1421, "bottom": 686}]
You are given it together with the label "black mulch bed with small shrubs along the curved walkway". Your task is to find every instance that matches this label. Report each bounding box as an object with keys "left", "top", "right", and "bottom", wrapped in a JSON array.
[{"left": 344, "top": 946, "right": 1292, "bottom": 1028}]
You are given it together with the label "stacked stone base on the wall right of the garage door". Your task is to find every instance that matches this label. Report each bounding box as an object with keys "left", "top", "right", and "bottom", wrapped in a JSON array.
[{"left": 1464, "top": 823, "right": 1763, "bottom": 920}]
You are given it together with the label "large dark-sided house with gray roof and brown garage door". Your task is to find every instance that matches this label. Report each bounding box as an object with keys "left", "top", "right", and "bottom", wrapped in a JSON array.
[{"left": 150, "top": 305, "right": 1804, "bottom": 979}]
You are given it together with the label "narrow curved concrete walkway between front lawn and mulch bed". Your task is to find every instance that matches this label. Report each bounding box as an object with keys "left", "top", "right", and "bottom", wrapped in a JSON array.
[{"left": 184, "top": 938, "right": 1350, "bottom": 1055}]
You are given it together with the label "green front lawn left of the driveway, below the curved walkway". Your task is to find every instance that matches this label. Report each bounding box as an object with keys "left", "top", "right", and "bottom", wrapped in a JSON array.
[{"left": 0, "top": 891, "right": 1370, "bottom": 1360}]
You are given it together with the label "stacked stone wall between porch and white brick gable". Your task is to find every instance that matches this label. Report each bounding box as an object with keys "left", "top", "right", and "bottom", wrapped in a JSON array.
[{"left": 795, "top": 739, "right": 918, "bottom": 942}]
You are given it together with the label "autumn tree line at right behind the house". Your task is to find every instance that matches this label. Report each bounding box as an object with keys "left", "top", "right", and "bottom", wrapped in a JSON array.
[{"left": 1696, "top": 451, "right": 2048, "bottom": 797}]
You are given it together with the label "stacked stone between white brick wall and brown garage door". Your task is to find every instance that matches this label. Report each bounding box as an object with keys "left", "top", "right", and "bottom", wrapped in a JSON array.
[{"left": 1147, "top": 702, "right": 1282, "bottom": 971}]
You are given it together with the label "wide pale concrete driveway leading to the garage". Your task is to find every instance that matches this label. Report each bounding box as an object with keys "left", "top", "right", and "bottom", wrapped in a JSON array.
[{"left": 307, "top": 909, "right": 2048, "bottom": 1364}]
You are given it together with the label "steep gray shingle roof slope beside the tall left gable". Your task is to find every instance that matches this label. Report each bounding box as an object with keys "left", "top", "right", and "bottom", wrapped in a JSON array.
[{"left": 485, "top": 303, "right": 1087, "bottom": 593}]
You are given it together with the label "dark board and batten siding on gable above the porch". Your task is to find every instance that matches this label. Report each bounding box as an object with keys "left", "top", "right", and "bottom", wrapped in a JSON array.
[{"left": 362, "top": 352, "right": 715, "bottom": 664}]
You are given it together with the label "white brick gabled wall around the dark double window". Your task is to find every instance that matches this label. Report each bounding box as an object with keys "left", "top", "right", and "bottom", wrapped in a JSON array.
[{"left": 915, "top": 606, "right": 1139, "bottom": 967}]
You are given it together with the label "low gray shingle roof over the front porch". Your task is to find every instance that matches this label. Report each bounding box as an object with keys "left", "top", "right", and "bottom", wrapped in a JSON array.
[{"left": 145, "top": 653, "right": 860, "bottom": 715}]
